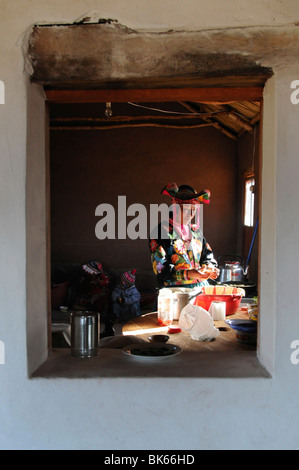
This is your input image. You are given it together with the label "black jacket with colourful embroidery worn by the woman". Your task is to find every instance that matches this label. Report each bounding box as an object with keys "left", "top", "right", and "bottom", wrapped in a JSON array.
[{"left": 149, "top": 220, "right": 217, "bottom": 287}]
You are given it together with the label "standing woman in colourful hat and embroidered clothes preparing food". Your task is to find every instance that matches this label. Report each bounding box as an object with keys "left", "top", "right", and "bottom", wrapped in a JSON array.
[{"left": 149, "top": 183, "right": 219, "bottom": 288}]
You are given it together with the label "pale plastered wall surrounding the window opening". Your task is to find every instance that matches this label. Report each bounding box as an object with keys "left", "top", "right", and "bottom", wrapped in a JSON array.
[{"left": 0, "top": 0, "right": 299, "bottom": 449}]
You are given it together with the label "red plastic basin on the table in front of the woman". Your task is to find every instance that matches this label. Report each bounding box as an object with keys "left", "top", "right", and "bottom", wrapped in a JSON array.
[{"left": 194, "top": 286, "right": 245, "bottom": 315}]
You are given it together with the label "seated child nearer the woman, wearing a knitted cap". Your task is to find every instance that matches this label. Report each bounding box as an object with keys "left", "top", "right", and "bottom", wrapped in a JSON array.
[{"left": 112, "top": 269, "right": 140, "bottom": 319}]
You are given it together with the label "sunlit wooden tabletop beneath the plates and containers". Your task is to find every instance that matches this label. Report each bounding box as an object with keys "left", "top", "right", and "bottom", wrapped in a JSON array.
[{"left": 122, "top": 310, "right": 256, "bottom": 351}]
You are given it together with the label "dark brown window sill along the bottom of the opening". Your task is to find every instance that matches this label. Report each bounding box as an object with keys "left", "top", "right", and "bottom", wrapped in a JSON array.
[{"left": 31, "top": 348, "right": 271, "bottom": 379}]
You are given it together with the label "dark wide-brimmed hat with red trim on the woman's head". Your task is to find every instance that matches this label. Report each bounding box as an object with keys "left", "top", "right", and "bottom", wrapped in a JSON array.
[{"left": 161, "top": 183, "right": 211, "bottom": 204}]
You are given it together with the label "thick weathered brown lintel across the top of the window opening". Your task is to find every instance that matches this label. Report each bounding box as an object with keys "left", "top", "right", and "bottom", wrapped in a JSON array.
[{"left": 27, "top": 22, "right": 299, "bottom": 87}]
